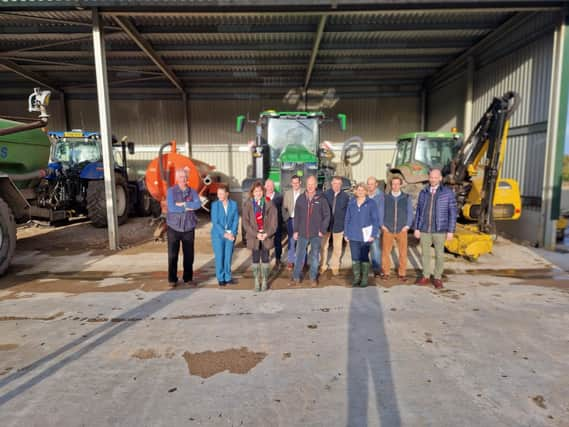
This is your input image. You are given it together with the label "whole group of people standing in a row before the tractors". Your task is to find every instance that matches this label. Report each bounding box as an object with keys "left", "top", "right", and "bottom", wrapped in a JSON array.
[{"left": 167, "top": 169, "right": 457, "bottom": 291}]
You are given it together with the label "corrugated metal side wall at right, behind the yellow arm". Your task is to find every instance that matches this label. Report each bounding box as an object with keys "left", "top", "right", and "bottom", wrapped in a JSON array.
[{"left": 427, "top": 14, "right": 557, "bottom": 243}]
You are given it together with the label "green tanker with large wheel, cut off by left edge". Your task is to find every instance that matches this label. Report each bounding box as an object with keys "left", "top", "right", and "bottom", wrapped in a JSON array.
[{"left": 0, "top": 89, "right": 50, "bottom": 275}]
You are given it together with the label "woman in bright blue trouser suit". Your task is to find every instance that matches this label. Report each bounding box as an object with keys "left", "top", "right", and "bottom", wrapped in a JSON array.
[{"left": 211, "top": 185, "right": 239, "bottom": 286}]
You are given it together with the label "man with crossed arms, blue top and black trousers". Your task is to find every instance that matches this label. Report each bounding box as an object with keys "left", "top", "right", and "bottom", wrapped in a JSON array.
[{"left": 166, "top": 169, "right": 201, "bottom": 287}]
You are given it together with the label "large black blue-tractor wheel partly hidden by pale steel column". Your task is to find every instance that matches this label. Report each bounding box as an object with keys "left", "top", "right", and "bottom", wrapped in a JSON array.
[{"left": 87, "top": 174, "right": 129, "bottom": 228}]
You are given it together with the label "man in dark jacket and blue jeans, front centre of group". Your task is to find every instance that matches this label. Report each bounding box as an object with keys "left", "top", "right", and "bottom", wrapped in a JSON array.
[{"left": 290, "top": 176, "right": 330, "bottom": 287}]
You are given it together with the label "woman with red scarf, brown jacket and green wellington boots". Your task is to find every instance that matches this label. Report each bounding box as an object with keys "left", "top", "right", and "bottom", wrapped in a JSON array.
[{"left": 243, "top": 181, "right": 277, "bottom": 292}]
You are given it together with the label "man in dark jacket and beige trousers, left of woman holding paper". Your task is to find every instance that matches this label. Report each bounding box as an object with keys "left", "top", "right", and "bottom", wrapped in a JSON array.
[{"left": 320, "top": 176, "right": 350, "bottom": 276}]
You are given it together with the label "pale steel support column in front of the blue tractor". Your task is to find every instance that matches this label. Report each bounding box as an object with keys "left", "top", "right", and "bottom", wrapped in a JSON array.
[{"left": 93, "top": 9, "right": 119, "bottom": 250}]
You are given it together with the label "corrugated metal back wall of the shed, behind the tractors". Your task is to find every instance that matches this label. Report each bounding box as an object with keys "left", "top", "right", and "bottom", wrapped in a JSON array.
[{"left": 0, "top": 97, "right": 408, "bottom": 189}]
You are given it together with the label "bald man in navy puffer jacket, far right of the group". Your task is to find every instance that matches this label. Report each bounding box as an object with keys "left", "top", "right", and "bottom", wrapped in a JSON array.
[{"left": 413, "top": 169, "right": 457, "bottom": 289}]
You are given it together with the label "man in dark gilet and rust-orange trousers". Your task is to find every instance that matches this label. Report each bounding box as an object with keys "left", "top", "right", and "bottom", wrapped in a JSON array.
[{"left": 381, "top": 176, "right": 413, "bottom": 282}]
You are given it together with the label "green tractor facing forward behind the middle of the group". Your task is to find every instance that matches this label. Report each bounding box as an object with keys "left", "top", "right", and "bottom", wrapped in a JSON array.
[{"left": 236, "top": 110, "right": 349, "bottom": 192}]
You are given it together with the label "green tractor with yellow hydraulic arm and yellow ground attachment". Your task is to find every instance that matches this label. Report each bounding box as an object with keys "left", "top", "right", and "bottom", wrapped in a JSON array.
[{"left": 387, "top": 92, "right": 522, "bottom": 260}]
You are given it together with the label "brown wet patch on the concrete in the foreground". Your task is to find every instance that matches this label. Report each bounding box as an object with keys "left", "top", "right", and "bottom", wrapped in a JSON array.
[{"left": 183, "top": 347, "right": 267, "bottom": 378}]
